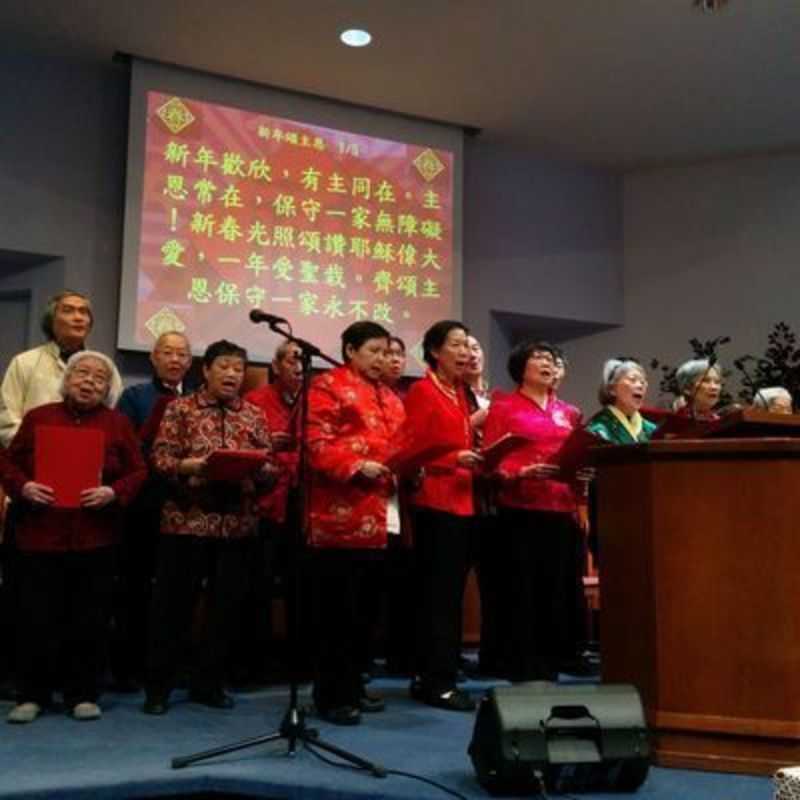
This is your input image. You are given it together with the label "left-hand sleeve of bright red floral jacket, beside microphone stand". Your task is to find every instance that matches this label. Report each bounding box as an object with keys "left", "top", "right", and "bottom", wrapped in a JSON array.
[{"left": 307, "top": 376, "right": 364, "bottom": 483}]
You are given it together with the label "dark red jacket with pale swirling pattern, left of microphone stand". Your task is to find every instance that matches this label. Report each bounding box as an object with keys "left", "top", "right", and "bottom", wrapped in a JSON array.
[{"left": 151, "top": 389, "right": 272, "bottom": 539}]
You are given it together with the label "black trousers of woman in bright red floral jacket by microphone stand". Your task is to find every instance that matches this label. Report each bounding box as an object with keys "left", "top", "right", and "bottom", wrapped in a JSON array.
[{"left": 308, "top": 550, "right": 380, "bottom": 711}]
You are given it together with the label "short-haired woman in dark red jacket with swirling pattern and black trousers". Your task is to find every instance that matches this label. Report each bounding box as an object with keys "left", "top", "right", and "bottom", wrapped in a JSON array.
[{"left": 143, "top": 339, "right": 274, "bottom": 714}]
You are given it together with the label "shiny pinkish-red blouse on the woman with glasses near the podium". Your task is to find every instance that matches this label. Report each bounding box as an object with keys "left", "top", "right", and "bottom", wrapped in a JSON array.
[{"left": 484, "top": 391, "right": 581, "bottom": 512}]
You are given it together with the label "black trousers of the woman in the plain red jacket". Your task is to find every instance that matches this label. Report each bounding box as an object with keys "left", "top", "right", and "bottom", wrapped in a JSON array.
[{"left": 414, "top": 508, "right": 476, "bottom": 694}]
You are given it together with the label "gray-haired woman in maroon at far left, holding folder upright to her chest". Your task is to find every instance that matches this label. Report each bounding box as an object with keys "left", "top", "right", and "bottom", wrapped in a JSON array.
[{"left": 0, "top": 350, "right": 147, "bottom": 723}]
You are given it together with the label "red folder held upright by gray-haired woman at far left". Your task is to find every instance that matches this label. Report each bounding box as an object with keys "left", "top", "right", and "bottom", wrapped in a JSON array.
[{"left": 33, "top": 425, "right": 106, "bottom": 508}]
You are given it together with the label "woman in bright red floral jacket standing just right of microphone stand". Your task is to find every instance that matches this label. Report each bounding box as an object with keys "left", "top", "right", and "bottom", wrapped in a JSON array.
[{"left": 307, "top": 321, "right": 405, "bottom": 725}]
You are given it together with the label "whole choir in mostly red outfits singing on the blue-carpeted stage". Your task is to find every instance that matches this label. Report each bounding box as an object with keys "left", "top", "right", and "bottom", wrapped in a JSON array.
[{"left": 0, "top": 291, "right": 791, "bottom": 725}]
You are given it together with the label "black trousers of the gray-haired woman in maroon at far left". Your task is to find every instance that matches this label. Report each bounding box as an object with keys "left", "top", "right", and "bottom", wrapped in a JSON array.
[{"left": 15, "top": 547, "right": 114, "bottom": 707}]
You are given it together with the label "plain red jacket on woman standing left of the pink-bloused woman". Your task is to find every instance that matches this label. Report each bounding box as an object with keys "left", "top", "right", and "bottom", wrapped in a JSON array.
[{"left": 403, "top": 371, "right": 475, "bottom": 516}]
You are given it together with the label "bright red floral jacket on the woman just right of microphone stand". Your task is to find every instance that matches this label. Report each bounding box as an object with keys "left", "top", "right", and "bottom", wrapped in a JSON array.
[{"left": 308, "top": 365, "right": 405, "bottom": 549}]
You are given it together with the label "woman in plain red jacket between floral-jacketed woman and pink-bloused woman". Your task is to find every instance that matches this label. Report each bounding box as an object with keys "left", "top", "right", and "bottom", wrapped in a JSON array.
[{"left": 403, "top": 320, "right": 481, "bottom": 711}]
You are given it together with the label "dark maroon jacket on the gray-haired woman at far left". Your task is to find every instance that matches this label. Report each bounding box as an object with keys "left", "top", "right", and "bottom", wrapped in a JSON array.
[{"left": 0, "top": 403, "right": 147, "bottom": 552}]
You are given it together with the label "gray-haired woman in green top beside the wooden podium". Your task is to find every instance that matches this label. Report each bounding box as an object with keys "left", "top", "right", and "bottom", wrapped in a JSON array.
[{"left": 586, "top": 358, "right": 656, "bottom": 444}]
